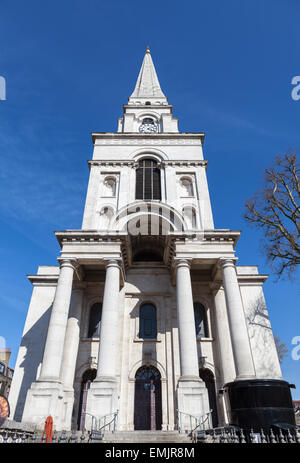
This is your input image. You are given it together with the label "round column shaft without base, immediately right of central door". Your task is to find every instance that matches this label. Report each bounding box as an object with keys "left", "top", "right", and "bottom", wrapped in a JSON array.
[{"left": 176, "top": 260, "right": 199, "bottom": 378}]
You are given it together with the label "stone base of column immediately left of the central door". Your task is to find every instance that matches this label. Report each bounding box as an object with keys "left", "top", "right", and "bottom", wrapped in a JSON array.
[{"left": 85, "top": 376, "right": 119, "bottom": 430}]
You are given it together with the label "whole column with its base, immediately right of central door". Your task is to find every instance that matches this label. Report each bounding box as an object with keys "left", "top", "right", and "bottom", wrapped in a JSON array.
[{"left": 176, "top": 259, "right": 209, "bottom": 430}]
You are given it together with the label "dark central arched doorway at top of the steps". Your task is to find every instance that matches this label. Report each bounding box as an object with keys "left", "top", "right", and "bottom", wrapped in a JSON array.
[{"left": 134, "top": 366, "right": 162, "bottom": 430}]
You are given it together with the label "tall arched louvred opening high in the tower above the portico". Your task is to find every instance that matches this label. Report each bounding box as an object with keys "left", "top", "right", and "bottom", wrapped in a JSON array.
[{"left": 135, "top": 159, "right": 161, "bottom": 200}]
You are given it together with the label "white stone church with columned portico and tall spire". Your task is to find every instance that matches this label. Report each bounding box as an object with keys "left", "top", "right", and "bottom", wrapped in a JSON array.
[{"left": 9, "top": 49, "right": 292, "bottom": 431}]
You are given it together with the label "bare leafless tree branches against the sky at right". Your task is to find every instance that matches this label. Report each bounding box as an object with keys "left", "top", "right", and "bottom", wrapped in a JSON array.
[{"left": 244, "top": 153, "right": 300, "bottom": 277}]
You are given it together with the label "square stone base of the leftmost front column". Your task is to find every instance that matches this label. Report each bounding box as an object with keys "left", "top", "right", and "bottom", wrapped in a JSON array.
[{"left": 22, "top": 379, "right": 64, "bottom": 431}]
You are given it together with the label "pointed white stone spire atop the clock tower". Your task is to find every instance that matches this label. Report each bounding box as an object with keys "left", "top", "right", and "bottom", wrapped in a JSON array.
[{"left": 129, "top": 47, "right": 166, "bottom": 101}]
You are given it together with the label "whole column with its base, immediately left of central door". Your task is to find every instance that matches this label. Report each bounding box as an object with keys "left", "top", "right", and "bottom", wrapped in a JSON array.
[{"left": 85, "top": 260, "right": 120, "bottom": 429}]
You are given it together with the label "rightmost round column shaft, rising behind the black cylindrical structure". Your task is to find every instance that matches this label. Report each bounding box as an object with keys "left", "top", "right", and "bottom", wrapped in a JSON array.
[{"left": 220, "top": 258, "right": 255, "bottom": 380}]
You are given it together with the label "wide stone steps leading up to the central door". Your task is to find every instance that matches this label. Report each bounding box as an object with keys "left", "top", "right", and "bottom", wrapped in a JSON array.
[{"left": 103, "top": 431, "right": 192, "bottom": 443}]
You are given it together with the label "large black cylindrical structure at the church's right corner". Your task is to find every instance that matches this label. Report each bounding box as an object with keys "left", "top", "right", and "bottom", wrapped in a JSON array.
[{"left": 224, "top": 379, "right": 295, "bottom": 432}]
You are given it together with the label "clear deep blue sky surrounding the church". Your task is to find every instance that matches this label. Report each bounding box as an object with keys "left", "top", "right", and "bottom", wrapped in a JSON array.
[{"left": 0, "top": 0, "right": 300, "bottom": 399}]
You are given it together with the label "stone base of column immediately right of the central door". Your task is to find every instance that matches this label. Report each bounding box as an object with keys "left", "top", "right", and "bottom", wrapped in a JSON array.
[{"left": 177, "top": 376, "right": 210, "bottom": 431}]
